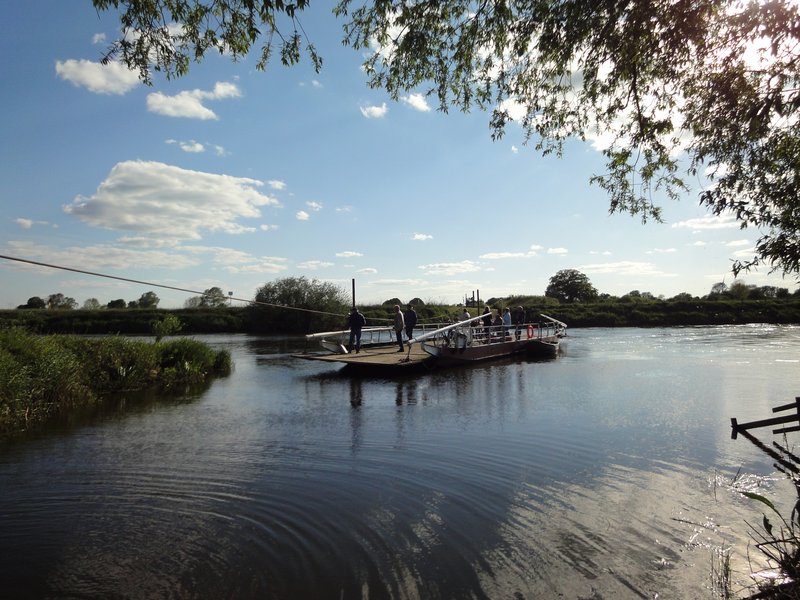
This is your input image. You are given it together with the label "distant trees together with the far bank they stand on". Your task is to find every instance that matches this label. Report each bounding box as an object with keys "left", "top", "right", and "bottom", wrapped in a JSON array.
[{"left": 7, "top": 269, "right": 800, "bottom": 334}]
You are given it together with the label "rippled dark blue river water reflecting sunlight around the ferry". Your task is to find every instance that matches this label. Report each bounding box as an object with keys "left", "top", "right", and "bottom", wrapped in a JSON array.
[{"left": 0, "top": 325, "right": 800, "bottom": 599}]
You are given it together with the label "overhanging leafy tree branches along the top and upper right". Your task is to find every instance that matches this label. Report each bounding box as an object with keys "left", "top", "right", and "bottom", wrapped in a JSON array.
[{"left": 93, "top": 0, "right": 800, "bottom": 276}]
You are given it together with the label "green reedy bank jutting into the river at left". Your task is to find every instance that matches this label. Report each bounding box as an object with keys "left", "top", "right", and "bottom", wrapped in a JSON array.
[{"left": 0, "top": 328, "right": 231, "bottom": 437}]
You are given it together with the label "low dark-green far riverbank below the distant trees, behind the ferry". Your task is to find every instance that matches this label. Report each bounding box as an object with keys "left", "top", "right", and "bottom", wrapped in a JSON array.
[{"left": 0, "top": 297, "right": 800, "bottom": 335}]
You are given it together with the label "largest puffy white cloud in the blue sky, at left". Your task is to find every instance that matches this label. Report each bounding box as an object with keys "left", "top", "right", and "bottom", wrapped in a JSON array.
[{"left": 64, "top": 161, "right": 280, "bottom": 239}]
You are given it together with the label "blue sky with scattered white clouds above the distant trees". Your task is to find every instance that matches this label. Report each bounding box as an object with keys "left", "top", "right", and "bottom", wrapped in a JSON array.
[{"left": 0, "top": 0, "right": 797, "bottom": 308}]
